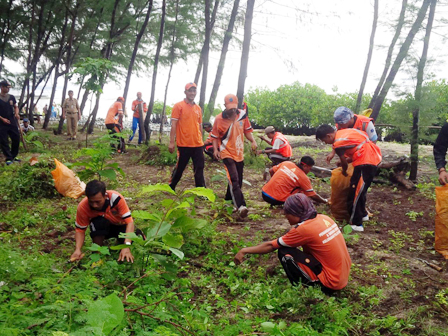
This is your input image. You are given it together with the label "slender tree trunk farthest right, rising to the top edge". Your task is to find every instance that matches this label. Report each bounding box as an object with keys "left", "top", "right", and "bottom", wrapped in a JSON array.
[{"left": 409, "top": 0, "right": 437, "bottom": 181}]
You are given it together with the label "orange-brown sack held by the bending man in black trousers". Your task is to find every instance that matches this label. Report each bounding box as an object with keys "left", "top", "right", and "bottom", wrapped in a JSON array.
[{"left": 330, "top": 164, "right": 353, "bottom": 222}]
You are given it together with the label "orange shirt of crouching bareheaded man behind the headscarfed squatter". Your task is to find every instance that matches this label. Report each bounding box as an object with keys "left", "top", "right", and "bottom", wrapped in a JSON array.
[{"left": 262, "top": 161, "right": 316, "bottom": 202}]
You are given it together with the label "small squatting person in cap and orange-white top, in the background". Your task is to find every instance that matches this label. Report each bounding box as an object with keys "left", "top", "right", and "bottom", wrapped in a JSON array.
[{"left": 257, "top": 126, "right": 292, "bottom": 165}]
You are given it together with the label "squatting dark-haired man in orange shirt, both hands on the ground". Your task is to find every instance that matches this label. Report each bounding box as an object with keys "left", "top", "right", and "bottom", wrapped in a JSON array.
[{"left": 70, "top": 180, "right": 143, "bottom": 262}]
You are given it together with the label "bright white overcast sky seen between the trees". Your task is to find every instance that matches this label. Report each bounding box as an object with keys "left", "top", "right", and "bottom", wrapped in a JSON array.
[{"left": 7, "top": 0, "right": 448, "bottom": 117}]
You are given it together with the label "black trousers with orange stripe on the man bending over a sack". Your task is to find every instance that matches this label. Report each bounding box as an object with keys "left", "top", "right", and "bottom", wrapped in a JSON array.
[{"left": 347, "top": 165, "right": 377, "bottom": 226}]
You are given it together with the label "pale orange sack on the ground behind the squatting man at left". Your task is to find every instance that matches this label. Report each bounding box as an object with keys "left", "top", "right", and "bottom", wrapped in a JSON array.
[{"left": 51, "top": 159, "right": 86, "bottom": 198}]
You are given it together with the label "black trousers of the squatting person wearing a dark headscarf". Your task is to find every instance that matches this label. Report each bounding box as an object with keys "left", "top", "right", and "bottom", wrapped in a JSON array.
[{"left": 278, "top": 247, "right": 334, "bottom": 294}]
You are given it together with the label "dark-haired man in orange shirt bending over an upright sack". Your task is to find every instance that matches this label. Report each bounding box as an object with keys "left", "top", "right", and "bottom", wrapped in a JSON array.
[{"left": 316, "top": 125, "right": 382, "bottom": 232}]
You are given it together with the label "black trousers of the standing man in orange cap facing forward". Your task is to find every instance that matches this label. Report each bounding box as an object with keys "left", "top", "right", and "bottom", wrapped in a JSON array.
[{"left": 170, "top": 146, "right": 205, "bottom": 190}]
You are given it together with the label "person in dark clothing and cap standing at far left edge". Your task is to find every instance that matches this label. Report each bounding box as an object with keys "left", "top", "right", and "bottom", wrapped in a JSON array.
[{"left": 0, "top": 80, "right": 20, "bottom": 166}]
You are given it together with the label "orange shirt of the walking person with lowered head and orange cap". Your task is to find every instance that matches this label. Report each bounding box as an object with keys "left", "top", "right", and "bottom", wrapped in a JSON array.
[{"left": 210, "top": 110, "right": 254, "bottom": 162}]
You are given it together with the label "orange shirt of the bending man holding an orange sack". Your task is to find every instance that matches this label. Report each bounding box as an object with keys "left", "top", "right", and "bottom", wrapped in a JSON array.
[{"left": 333, "top": 128, "right": 382, "bottom": 167}]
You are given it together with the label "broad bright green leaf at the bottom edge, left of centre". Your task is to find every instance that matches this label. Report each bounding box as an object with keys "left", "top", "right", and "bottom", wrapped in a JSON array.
[{"left": 87, "top": 294, "right": 124, "bottom": 335}]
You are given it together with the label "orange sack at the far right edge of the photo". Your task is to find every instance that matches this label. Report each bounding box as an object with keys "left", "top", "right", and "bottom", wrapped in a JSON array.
[{"left": 435, "top": 185, "right": 448, "bottom": 259}]
